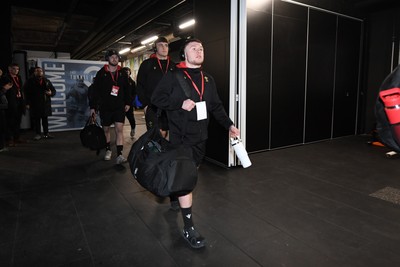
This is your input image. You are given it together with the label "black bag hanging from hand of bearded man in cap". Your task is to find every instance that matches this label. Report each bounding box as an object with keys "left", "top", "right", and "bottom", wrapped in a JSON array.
[{"left": 80, "top": 117, "right": 107, "bottom": 155}]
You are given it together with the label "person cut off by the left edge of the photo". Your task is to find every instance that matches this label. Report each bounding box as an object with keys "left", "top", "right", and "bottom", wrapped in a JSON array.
[{"left": 0, "top": 77, "right": 13, "bottom": 152}]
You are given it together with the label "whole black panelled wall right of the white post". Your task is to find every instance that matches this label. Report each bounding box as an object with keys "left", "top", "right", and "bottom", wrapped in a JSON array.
[{"left": 246, "top": 0, "right": 363, "bottom": 152}]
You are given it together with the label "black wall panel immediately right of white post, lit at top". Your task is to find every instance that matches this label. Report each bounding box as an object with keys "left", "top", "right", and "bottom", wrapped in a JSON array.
[{"left": 246, "top": 2, "right": 272, "bottom": 152}]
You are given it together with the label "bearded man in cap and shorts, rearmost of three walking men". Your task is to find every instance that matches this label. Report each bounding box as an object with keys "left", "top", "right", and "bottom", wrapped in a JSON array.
[{"left": 89, "top": 50, "right": 132, "bottom": 164}]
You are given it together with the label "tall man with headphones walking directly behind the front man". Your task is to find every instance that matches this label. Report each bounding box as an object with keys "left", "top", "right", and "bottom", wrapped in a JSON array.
[{"left": 136, "top": 37, "right": 179, "bottom": 211}]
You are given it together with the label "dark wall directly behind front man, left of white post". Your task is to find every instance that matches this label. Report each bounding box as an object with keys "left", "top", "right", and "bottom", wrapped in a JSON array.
[{"left": 194, "top": 0, "right": 233, "bottom": 166}]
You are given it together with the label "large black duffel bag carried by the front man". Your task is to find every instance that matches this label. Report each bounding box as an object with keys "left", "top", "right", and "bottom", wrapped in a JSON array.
[{"left": 128, "top": 126, "right": 197, "bottom": 197}]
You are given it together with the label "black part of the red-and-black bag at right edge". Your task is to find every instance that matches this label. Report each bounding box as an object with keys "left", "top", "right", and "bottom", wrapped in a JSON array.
[{"left": 375, "top": 65, "right": 400, "bottom": 152}]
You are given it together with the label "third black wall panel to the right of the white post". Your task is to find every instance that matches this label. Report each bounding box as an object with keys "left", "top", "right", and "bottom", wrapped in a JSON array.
[{"left": 305, "top": 10, "right": 337, "bottom": 143}]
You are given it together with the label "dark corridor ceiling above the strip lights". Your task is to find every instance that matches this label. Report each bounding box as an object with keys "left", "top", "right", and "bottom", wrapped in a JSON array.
[{"left": 11, "top": 0, "right": 399, "bottom": 60}]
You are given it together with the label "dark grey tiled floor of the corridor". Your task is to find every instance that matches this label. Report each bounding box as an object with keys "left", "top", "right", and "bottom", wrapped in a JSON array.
[{"left": 0, "top": 112, "right": 400, "bottom": 267}]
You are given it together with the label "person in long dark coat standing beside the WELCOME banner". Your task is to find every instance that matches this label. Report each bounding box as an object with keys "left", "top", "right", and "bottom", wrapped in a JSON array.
[{"left": 23, "top": 67, "right": 56, "bottom": 141}]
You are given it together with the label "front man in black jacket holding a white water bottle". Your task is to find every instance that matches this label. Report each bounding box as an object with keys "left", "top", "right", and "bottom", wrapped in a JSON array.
[{"left": 151, "top": 39, "right": 240, "bottom": 248}]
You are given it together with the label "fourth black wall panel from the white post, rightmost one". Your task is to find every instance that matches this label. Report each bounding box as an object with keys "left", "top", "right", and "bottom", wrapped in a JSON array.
[{"left": 333, "top": 17, "right": 362, "bottom": 137}]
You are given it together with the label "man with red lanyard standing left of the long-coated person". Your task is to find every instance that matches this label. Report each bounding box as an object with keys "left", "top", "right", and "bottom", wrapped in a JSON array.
[{"left": 5, "top": 63, "right": 26, "bottom": 146}]
